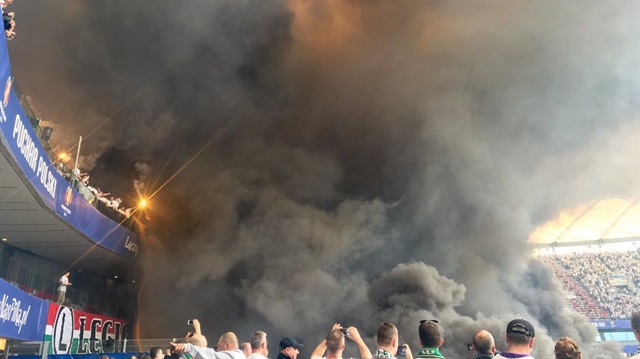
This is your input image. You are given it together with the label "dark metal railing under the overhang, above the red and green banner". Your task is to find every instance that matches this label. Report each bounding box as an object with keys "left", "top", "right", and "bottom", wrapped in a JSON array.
[{"left": 6, "top": 257, "right": 118, "bottom": 317}]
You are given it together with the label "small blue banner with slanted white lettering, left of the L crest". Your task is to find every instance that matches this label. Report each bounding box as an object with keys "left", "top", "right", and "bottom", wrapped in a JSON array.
[{"left": 0, "top": 279, "right": 49, "bottom": 341}]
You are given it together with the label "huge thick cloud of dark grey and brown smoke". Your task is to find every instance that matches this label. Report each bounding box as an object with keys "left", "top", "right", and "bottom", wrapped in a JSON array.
[{"left": 11, "top": 0, "right": 640, "bottom": 358}]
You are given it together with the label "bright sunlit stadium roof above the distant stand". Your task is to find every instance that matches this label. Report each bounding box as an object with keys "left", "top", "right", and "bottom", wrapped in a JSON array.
[{"left": 529, "top": 198, "right": 640, "bottom": 244}]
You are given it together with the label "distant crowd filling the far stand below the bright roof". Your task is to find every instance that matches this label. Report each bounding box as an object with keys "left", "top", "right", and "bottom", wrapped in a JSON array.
[{"left": 542, "top": 250, "right": 640, "bottom": 319}]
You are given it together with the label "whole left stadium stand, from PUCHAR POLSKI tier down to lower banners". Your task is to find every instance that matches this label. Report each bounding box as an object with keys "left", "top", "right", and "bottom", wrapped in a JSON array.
[{"left": 0, "top": 32, "right": 140, "bottom": 355}]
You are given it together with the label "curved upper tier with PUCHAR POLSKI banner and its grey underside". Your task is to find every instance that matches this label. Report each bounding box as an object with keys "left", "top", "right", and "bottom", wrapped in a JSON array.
[{"left": 0, "top": 31, "right": 138, "bottom": 279}]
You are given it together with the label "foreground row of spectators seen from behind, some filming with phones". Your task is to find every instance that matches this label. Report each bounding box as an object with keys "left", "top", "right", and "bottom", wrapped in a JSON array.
[{"left": 132, "top": 312, "right": 640, "bottom": 359}]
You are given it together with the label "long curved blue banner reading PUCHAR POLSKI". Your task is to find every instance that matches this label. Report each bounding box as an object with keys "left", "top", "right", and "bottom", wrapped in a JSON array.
[{"left": 0, "top": 40, "right": 138, "bottom": 258}]
